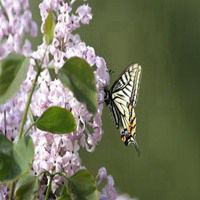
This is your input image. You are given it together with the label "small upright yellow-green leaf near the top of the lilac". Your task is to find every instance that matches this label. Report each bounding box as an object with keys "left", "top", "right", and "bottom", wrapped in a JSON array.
[{"left": 44, "top": 10, "right": 55, "bottom": 44}]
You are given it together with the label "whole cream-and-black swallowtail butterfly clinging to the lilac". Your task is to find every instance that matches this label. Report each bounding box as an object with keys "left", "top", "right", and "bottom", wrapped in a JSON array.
[{"left": 104, "top": 64, "right": 142, "bottom": 154}]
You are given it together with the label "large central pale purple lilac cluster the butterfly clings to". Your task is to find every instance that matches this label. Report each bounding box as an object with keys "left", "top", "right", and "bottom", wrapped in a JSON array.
[{"left": 31, "top": 0, "right": 109, "bottom": 183}]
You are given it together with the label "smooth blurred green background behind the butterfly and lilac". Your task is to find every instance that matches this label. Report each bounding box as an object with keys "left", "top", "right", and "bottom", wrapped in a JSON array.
[{"left": 31, "top": 0, "right": 200, "bottom": 200}]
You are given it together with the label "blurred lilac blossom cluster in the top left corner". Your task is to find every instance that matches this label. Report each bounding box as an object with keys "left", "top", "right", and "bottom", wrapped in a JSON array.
[{"left": 0, "top": 0, "right": 37, "bottom": 58}]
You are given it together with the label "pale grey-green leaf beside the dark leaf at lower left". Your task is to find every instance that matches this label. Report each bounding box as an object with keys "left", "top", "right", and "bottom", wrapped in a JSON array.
[{"left": 13, "top": 136, "right": 34, "bottom": 174}]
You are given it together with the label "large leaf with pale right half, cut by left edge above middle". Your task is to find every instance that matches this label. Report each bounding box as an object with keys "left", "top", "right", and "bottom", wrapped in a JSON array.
[{"left": 0, "top": 54, "right": 29, "bottom": 104}]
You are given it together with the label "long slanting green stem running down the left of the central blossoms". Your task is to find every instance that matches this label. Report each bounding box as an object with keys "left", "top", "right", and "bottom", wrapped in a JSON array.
[{"left": 19, "top": 67, "right": 41, "bottom": 139}]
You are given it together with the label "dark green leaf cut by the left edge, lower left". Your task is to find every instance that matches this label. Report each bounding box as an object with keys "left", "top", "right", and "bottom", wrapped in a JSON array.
[{"left": 0, "top": 133, "right": 21, "bottom": 182}]
